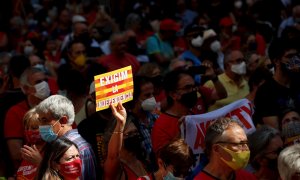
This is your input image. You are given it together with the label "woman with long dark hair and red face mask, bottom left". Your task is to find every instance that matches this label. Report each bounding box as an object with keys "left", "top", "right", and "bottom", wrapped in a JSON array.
[{"left": 36, "top": 137, "right": 82, "bottom": 180}]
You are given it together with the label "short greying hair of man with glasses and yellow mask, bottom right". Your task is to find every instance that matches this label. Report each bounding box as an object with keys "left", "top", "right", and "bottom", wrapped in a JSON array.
[{"left": 204, "top": 117, "right": 242, "bottom": 156}]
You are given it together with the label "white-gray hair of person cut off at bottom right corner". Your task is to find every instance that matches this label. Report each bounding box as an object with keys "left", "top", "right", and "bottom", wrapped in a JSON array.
[{"left": 278, "top": 144, "right": 300, "bottom": 180}]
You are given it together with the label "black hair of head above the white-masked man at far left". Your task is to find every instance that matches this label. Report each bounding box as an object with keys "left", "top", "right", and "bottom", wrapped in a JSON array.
[{"left": 9, "top": 55, "right": 30, "bottom": 78}]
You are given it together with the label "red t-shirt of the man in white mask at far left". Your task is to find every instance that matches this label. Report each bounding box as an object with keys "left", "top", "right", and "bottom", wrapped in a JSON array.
[{"left": 4, "top": 100, "right": 30, "bottom": 138}]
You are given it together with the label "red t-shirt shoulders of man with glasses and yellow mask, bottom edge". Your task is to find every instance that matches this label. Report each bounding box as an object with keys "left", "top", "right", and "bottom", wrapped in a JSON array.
[{"left": 194, "top": 170, "right": 256, "bottom": 180}]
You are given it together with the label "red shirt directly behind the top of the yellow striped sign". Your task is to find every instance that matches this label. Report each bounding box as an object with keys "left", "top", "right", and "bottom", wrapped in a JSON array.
[{"left": 97, "top": 53, "right": 140, "bottom": 74}]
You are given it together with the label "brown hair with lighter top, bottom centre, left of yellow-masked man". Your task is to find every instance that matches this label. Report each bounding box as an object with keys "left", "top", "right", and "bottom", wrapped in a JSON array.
[{"left": 158, "top": 139, "right": 194, "bottom": 176}]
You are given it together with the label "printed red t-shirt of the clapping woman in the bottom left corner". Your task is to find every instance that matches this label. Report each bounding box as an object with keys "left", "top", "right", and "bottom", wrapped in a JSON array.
[{"left": 17, "top": 160, "right": 37, "bottom": 180}]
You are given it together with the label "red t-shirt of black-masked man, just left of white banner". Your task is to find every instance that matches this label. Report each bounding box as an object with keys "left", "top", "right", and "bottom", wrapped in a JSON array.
[{"left": 151, "top": 113, "right": 179, "bottom": 153}]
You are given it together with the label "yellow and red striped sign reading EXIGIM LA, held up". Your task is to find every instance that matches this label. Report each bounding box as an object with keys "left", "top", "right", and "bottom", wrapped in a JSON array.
[{"left": 94, "top": 66, "right": 133, "bottom": 111}]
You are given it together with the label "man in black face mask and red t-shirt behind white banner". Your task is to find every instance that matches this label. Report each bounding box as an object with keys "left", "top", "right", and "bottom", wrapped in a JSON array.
[{"left": 151, "top": 68, "right": 226, "bottom": 155}]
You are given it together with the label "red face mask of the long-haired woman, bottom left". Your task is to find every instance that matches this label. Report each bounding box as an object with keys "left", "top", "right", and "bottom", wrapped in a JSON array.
[{"left": 59, "top": 158, "right": 81, "bottom": 179}]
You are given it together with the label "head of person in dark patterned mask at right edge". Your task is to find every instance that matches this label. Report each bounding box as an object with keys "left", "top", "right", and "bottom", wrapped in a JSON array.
[{"left": 280, "top": 108, "right": 300, "bottom": 146}]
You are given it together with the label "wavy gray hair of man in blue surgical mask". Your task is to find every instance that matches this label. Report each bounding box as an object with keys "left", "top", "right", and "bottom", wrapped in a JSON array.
[{"left": 36, "top": 95, "right": 75, "bottom": 125}]
